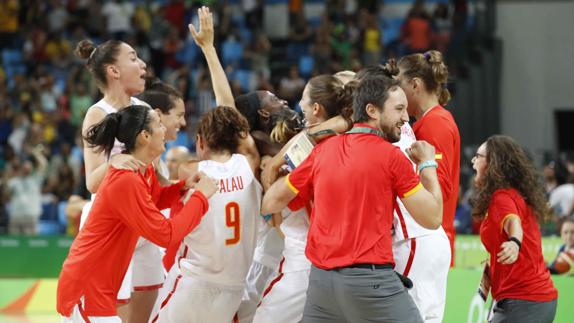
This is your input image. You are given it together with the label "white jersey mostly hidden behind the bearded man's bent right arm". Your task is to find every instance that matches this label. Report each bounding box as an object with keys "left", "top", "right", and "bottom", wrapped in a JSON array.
[{"left": 393, "top": 123, "right": 443, "bottom": 243}]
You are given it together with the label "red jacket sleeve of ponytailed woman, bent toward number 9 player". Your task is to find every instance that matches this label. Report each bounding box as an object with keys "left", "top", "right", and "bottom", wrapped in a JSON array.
[{"left": 114, "top": 172, "right": 208, "bottom": 248}]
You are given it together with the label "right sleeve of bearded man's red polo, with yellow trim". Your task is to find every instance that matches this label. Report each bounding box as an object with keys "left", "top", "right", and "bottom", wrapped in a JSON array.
[{"left": 389, "top": 148, "right": 423, "bottom": 198}]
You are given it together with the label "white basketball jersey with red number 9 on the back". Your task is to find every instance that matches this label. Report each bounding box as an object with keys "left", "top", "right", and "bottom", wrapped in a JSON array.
[{"left": 178, "top": 154, "right": 262, "bottom": 288}]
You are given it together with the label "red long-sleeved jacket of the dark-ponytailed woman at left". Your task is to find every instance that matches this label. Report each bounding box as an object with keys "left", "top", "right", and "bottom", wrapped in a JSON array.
[{"left": 57, "top": 167, "right": 208, "bottom": 316}]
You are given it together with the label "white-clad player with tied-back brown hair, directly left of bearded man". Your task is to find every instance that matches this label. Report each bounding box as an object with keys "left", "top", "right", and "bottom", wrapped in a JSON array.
[{"left": 253, "top": 75, "right": 352, "bottom": 322}]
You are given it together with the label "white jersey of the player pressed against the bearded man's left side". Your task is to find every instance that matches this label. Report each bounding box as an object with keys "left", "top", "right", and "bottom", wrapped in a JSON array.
[{"left": 281, "top": 207, "right": 311, "bottom": 273}]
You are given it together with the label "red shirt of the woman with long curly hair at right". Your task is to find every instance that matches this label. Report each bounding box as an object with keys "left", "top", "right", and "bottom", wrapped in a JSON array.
[{"left": 480, "top": 189, "right": 558, "bottom": 302}]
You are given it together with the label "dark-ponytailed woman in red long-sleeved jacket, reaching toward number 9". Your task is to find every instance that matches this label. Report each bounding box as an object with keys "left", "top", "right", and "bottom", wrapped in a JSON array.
[{"left": 57, "top": 106, "right": 218, "bottom": 322}]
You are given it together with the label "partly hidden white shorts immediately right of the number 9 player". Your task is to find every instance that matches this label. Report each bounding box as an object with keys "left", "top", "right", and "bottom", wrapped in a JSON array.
[{"left": 237, "top": 261, "right": 277, "bottom": 323}]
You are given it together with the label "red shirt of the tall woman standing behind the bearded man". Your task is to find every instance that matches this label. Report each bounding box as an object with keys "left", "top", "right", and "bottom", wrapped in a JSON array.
[{"left": 413, "top": 105, "right": 460, "bottom": 263}]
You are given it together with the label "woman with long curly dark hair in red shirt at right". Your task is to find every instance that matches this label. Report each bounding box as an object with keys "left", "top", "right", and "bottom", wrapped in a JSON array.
[{"left": 472, "top": 136, "right": 558, "bottom": 323}]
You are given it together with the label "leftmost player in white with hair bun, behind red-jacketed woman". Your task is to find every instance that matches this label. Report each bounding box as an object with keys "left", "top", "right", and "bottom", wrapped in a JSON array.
[{"left": 75, "top": 40, "right": 150, "bottom": 320}]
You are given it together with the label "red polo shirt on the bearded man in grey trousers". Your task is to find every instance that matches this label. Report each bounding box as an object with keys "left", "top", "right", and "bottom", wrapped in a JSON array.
[{"left": 287, "top": 124, "right": 422, "bottom": 269}]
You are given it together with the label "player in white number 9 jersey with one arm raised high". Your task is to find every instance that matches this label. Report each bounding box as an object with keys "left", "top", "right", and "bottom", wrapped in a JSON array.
[{"left": 152, "top": 7, "right": 261, "bottom": 322}]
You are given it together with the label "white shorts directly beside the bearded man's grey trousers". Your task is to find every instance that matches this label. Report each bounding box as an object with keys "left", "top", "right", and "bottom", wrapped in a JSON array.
[{"left": 253, "top": 269, "right": 310, "bottom": 323}]
